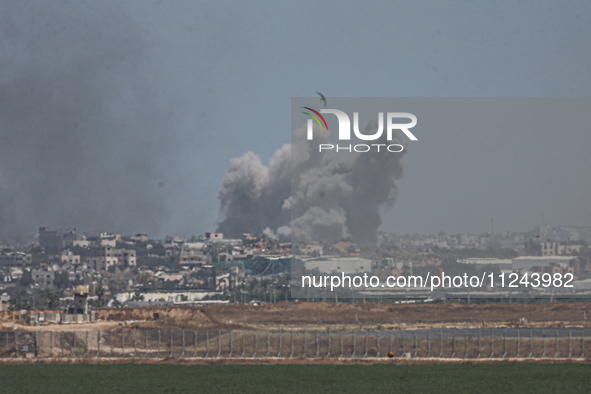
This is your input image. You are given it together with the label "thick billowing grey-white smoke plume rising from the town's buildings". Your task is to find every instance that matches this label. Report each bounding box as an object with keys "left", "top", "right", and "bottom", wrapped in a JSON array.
[{"left": 218, "top": 122, "right": 408, "bottom": 243}]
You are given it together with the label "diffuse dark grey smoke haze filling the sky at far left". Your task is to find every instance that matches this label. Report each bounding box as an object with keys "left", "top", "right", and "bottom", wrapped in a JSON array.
[{"left": 0, "top": 1, "right": 172, "bottom": 237}]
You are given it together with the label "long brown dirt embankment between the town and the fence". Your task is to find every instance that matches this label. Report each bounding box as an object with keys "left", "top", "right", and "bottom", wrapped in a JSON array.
[{"left": 0, "top": 302, "right": 591, "bottom": 329}]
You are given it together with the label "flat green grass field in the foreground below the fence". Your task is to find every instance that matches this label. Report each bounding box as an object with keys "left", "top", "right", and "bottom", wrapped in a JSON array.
[{"left": 0, "top": 364, "right": 591, "bottom": 394}]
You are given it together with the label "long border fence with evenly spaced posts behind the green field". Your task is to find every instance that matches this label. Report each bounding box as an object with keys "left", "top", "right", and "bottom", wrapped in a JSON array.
[{"left": 0, "top": 328, "right": 591, "bottom": 359}]
